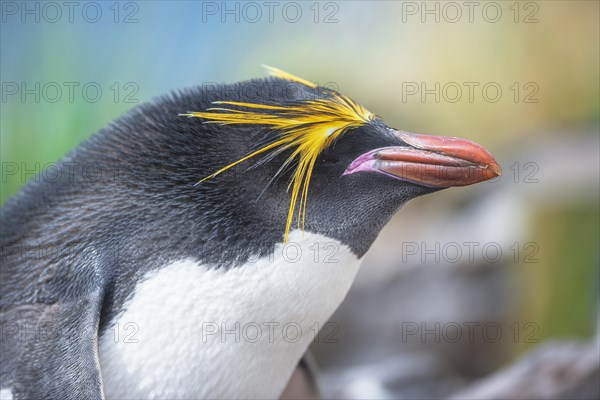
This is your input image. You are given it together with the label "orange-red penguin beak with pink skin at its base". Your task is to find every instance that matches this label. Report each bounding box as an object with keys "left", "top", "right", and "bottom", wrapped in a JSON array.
[{"left": 344, "top": 131, "right": 502, "bottom": 188}]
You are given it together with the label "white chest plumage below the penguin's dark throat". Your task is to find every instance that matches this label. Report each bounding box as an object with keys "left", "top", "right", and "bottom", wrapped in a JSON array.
[{"left": 99, "top": 231, "right": 359, "bottom": 399}]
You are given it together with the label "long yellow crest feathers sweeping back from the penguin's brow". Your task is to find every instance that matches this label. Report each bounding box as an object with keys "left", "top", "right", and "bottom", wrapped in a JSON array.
[{"left": 180, "top": 67, "right": 374, "bottom": 243}]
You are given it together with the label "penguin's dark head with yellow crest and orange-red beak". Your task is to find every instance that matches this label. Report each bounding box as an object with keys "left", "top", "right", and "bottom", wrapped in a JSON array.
[{"left": 180, "top": 68, "right": 500, "bottom": 256}]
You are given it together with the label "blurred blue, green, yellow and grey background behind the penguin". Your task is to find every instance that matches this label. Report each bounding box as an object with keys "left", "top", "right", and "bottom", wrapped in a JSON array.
[{"left": 0, "top": 1, "right": 600, "bottom": 398}]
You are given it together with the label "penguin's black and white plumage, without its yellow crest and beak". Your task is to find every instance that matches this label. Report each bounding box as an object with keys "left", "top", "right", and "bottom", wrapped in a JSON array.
[{"left": 0, "top": 70, "right": 500, "bottom": 399}]
